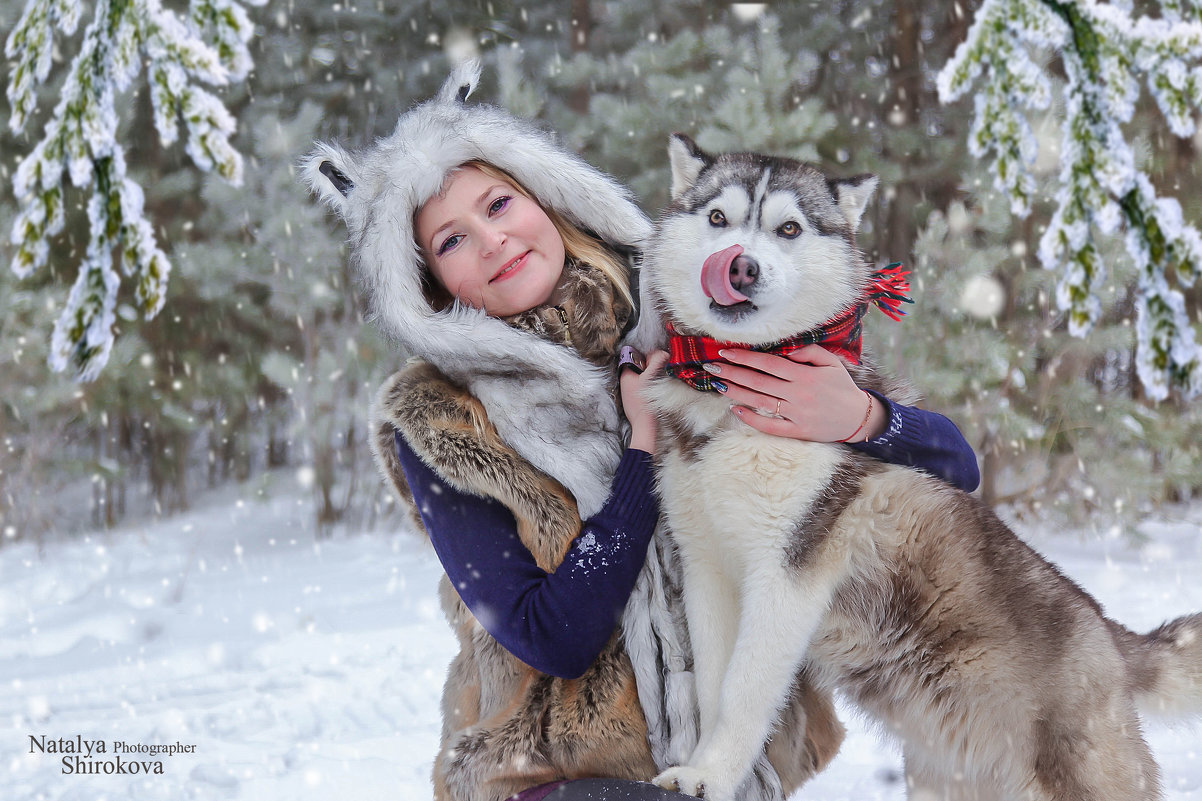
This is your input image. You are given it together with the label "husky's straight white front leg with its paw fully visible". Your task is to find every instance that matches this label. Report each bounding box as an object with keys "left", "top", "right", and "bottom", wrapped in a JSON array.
[{"left": 655, "top": 566, "right": 839, "bottom": 801}]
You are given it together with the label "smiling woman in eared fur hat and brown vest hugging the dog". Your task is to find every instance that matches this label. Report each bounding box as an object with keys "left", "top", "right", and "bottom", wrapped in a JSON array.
[{"left": 304, "top": 65, "right": 975, "bottom": 801}]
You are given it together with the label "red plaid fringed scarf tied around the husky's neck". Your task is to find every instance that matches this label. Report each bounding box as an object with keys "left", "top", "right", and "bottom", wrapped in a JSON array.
[{"left": 665, "top": 262, "right": 914, "bottom": 392}]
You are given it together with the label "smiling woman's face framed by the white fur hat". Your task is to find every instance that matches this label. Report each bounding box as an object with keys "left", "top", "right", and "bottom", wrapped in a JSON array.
[{"left": 416, "top": 167, "right": 565, "bottom": 318}]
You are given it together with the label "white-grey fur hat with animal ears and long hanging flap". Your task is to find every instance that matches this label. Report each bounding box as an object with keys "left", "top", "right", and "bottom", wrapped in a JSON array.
[{"left": 302, "top": 61, "right": 650, "bottom": 512}]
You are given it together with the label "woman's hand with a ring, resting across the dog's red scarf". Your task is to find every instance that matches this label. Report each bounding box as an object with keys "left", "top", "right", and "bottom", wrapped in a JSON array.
[{"left": 706, "top": 345, "right": 888, "bottom": 443}]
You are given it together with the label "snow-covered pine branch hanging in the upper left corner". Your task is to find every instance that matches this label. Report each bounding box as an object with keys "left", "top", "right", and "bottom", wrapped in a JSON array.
[{"left": 5, "top": 0, "right": 266, "bottom": 380}]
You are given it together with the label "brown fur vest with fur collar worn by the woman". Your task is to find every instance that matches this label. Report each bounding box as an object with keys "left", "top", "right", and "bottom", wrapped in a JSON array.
[{"left": 373, "top": 266, "right": 655, "bottom": 801}]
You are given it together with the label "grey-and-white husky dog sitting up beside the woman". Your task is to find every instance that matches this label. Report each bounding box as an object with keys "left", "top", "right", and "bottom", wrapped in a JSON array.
[{"left": 641, "top": 135, "right": 1202, "bottom": 801}]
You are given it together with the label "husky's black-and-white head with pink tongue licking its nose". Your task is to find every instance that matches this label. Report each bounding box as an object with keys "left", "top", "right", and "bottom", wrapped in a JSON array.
[{"left": 642, "top": 134, "right": 876, "bottom": 345}]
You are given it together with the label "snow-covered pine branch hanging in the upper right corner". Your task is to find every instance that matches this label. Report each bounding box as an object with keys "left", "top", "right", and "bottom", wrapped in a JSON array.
[{"left": 938, "top": 0, "right": 1202, "bottom": 399}]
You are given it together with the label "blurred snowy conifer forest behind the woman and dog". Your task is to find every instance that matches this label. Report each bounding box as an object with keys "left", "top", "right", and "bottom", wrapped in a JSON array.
[{"left": 0, "top": 0, "right": 1202, "bottom": 541}]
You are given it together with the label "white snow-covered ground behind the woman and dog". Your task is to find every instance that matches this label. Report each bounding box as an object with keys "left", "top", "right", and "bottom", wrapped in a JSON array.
[{"left": 0, "top": 488, "right": 1202, "bottom": 801}]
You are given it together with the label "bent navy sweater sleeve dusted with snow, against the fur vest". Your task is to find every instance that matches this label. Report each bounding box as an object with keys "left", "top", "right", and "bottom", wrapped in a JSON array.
[{"left": 397, "top": 434, "right": 659, "bottom": 678}]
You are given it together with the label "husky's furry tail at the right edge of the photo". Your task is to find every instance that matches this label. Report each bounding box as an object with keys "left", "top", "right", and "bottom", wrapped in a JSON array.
[{"left": 1111, "top": 613, "right": 1202, "bottom": 718}]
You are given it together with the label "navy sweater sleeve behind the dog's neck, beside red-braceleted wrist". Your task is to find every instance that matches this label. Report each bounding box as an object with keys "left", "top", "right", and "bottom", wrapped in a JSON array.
[{"left": 851, "top": 392, "right": 981, "bottom": 492}]
